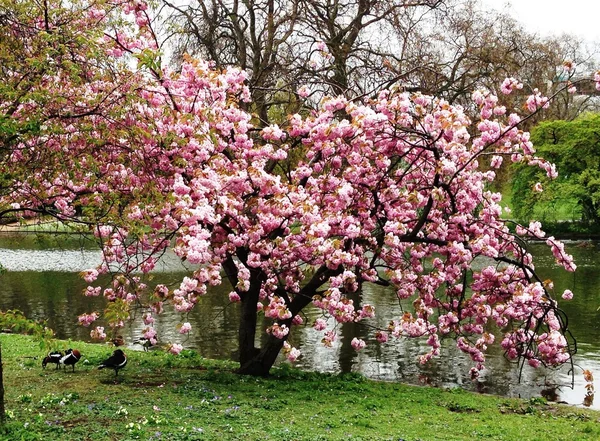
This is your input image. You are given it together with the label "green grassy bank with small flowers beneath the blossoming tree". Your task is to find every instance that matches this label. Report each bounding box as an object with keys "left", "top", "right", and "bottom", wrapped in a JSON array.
[{"left": 0, "top": 334, "right": 600, "bottom": 441}]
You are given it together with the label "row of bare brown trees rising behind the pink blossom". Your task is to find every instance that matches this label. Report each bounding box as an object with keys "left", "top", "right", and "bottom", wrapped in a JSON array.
[{"left": 166, "top": 0, "right": 596, "bottom": 126}]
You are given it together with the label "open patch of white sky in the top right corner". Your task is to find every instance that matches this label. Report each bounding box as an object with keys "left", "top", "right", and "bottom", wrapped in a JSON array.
[{"left": 481, "top": 0, "right": 600, "bottom": 43}]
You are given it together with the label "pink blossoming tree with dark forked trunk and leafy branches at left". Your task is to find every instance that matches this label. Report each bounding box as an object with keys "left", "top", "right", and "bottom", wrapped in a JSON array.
[{"left": 0, "top": 0, "right": 592, "bottom": 376}]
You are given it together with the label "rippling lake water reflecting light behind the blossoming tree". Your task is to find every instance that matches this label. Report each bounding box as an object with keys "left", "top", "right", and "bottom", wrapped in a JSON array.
[{"left": 0, "top": 235, "right": 600, "bottom": 409}]
